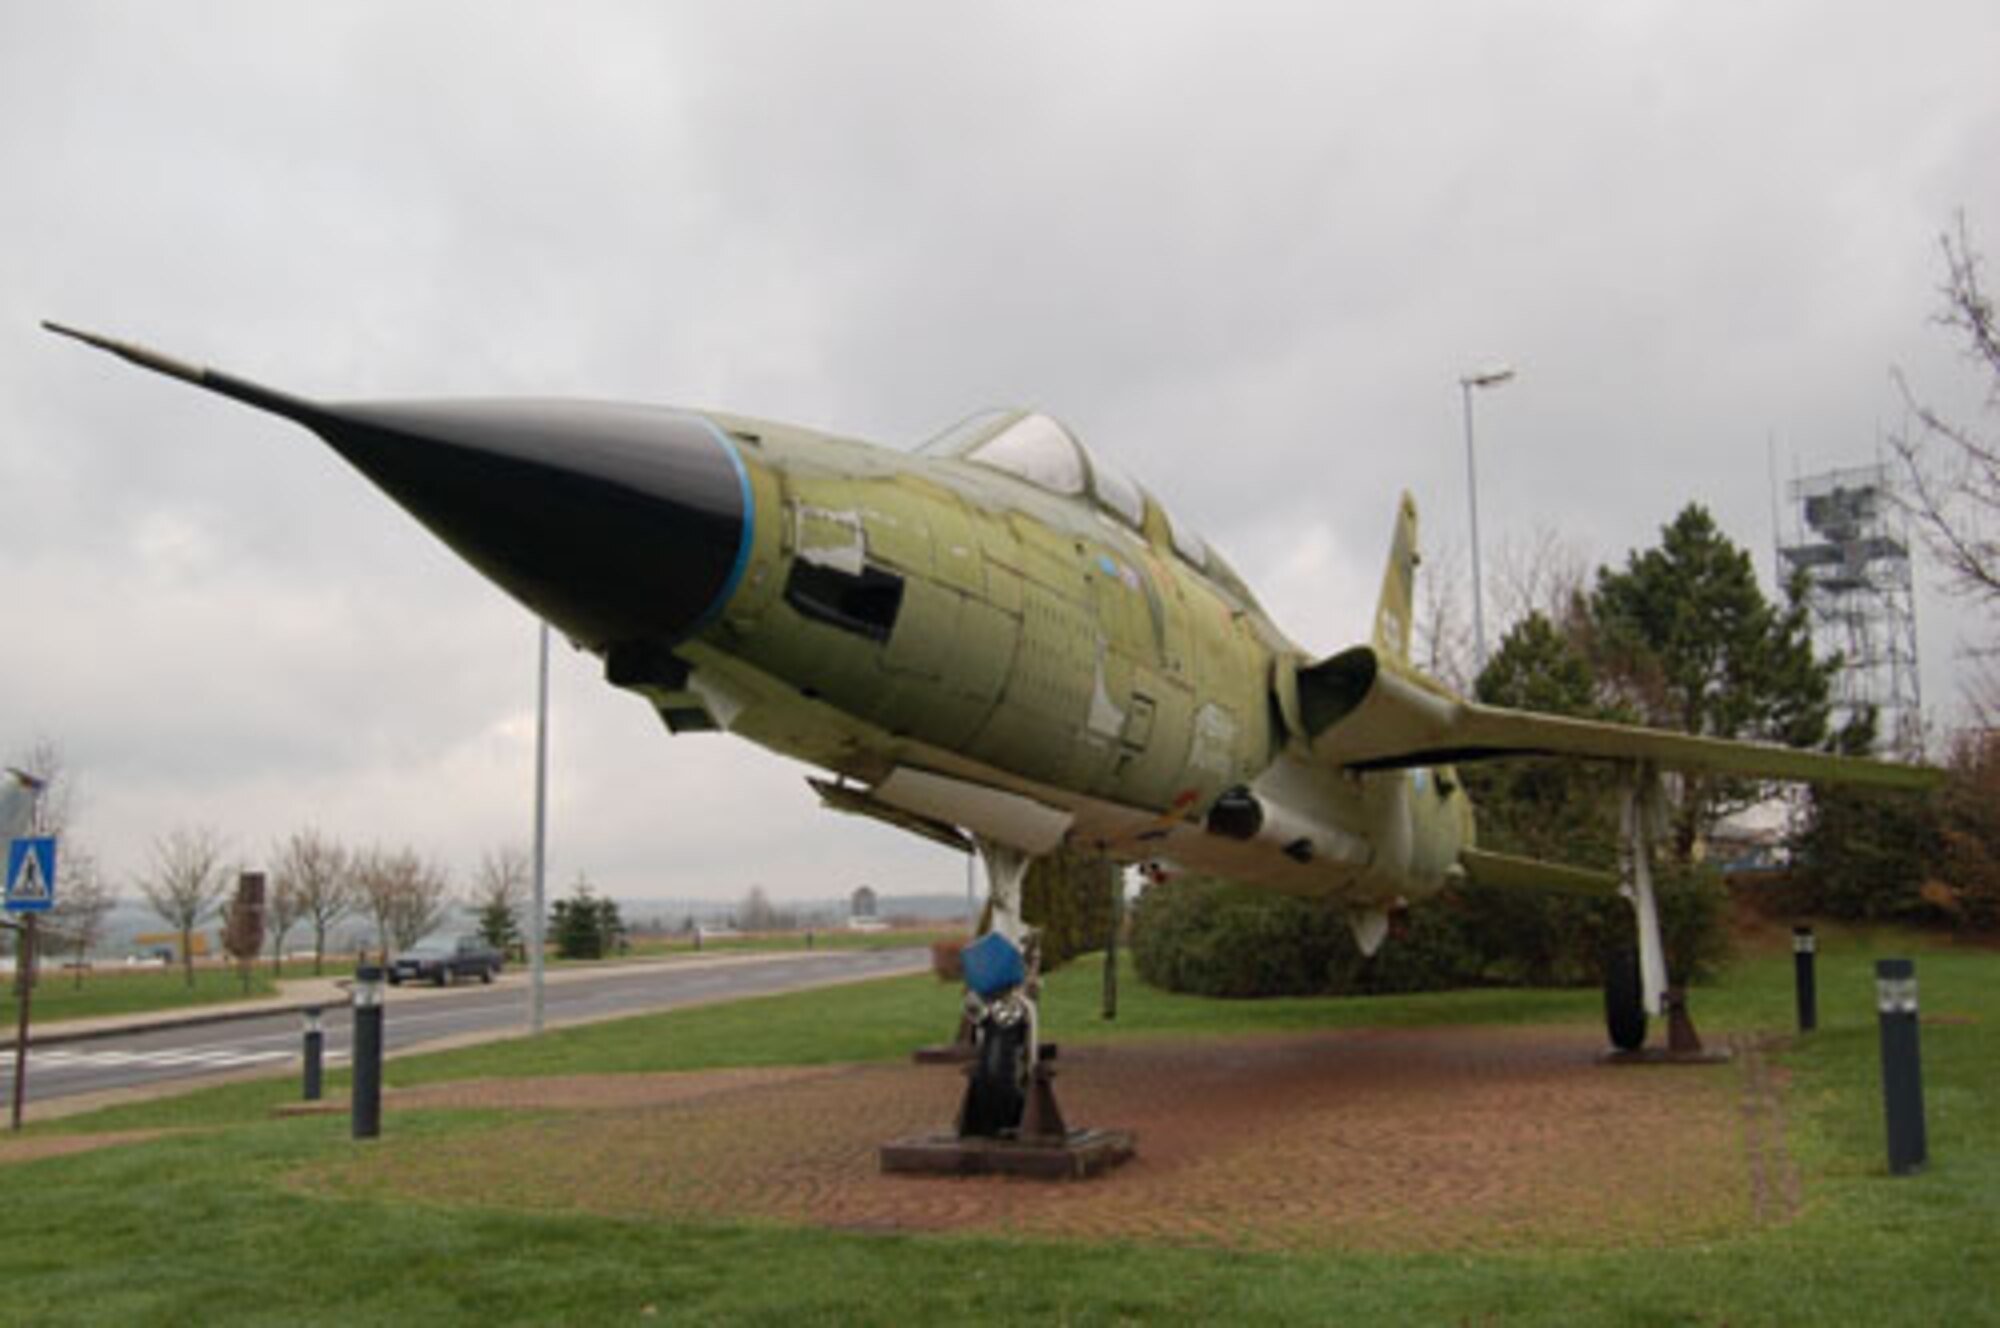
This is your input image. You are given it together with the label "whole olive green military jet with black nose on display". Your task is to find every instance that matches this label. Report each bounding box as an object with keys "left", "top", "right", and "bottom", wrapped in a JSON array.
[{"left": 44, "top": 324, "right": 1934, "bottom": 1132}]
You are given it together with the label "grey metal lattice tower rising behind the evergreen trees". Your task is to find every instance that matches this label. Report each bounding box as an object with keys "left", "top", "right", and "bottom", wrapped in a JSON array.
[{"left": 1778, "top": 464, "right": 1924, "bottom": 760}]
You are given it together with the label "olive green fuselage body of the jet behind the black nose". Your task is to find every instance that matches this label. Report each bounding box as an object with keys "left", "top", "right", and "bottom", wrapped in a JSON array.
[{"left": 634, "top": 414, "right": 1470, "bottom": 906}]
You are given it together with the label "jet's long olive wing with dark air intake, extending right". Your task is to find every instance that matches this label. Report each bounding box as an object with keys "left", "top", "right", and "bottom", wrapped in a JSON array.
[{"left": 1298, "top": 646, "right": 1944, "bottom": 790}]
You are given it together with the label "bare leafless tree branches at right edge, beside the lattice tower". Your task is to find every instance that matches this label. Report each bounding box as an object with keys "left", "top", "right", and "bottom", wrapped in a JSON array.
[{"left": 1890, "top": 214, "right": 2000, "bottom": 604}]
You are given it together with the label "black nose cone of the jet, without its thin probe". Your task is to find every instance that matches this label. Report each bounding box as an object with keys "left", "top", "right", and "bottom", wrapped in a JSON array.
[{"left": 302, "top": 400, "right": 752, "bottom": 650}]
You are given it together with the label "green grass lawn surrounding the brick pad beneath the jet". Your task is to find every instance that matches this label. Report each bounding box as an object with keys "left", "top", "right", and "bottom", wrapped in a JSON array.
[{"left": 0, "top": 934, "right": 2000, "bottom": 1324}]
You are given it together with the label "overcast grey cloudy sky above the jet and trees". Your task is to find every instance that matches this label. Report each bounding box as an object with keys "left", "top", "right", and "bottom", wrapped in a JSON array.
[{"left": 0, "top": 0, "right": 2000, "bottom": 898}]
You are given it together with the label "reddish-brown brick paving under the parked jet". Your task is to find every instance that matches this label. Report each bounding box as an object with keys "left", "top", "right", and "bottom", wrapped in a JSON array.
[{"left": 312, "top": 1028, "right": 1798, "bottom": 1250}]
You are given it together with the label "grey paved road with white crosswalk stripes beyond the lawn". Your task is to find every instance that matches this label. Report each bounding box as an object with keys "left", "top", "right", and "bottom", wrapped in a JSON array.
[{"left": 0, "top": 950, "right": 930, "bottom": 1104}]
